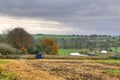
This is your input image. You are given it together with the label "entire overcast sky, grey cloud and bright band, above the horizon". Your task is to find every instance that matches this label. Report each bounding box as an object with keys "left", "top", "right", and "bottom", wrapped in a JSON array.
[{"left": 0, "top": 0, "right": 120, "bottom": 35}]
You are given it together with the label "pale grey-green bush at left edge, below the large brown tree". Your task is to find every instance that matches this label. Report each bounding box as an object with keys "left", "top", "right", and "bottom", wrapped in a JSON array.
[{"left": 0, "top": 43, "right": 21, "bottom": 55}]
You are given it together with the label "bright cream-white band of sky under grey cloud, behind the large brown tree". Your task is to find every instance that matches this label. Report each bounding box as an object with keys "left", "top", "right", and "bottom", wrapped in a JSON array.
[{"left": 0, "top": 16, "right": 72, "bottom": 34}]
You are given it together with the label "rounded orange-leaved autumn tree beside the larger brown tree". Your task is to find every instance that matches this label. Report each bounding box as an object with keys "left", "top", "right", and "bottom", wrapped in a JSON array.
[{"left": 40, "top": 38, "right": 58, "bottom": 55}]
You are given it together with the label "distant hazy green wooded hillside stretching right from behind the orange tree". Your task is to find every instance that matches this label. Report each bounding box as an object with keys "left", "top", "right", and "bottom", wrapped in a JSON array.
[{"left": 36, "top": 35, "right": 120, "bottom": 50}]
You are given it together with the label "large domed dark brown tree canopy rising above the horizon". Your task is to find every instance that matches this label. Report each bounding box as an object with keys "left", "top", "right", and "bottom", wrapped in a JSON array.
[{"left": 7, "top": 27, "right": 33, "bottom": 49}]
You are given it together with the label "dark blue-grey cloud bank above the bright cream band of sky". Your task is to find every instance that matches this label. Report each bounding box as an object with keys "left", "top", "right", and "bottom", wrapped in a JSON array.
[{"left": 0, "top": 0, "right": 120, "bottom": 34}]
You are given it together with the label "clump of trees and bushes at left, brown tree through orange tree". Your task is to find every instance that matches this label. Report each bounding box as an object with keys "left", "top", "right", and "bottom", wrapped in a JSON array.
[{"left": 0, "top": 27, "right": 58, "bottom": 54}]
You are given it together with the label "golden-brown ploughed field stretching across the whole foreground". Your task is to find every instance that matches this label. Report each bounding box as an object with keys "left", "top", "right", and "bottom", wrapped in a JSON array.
[{"left": 0, "top": 59, "right": 120, "bottom": 80}]
